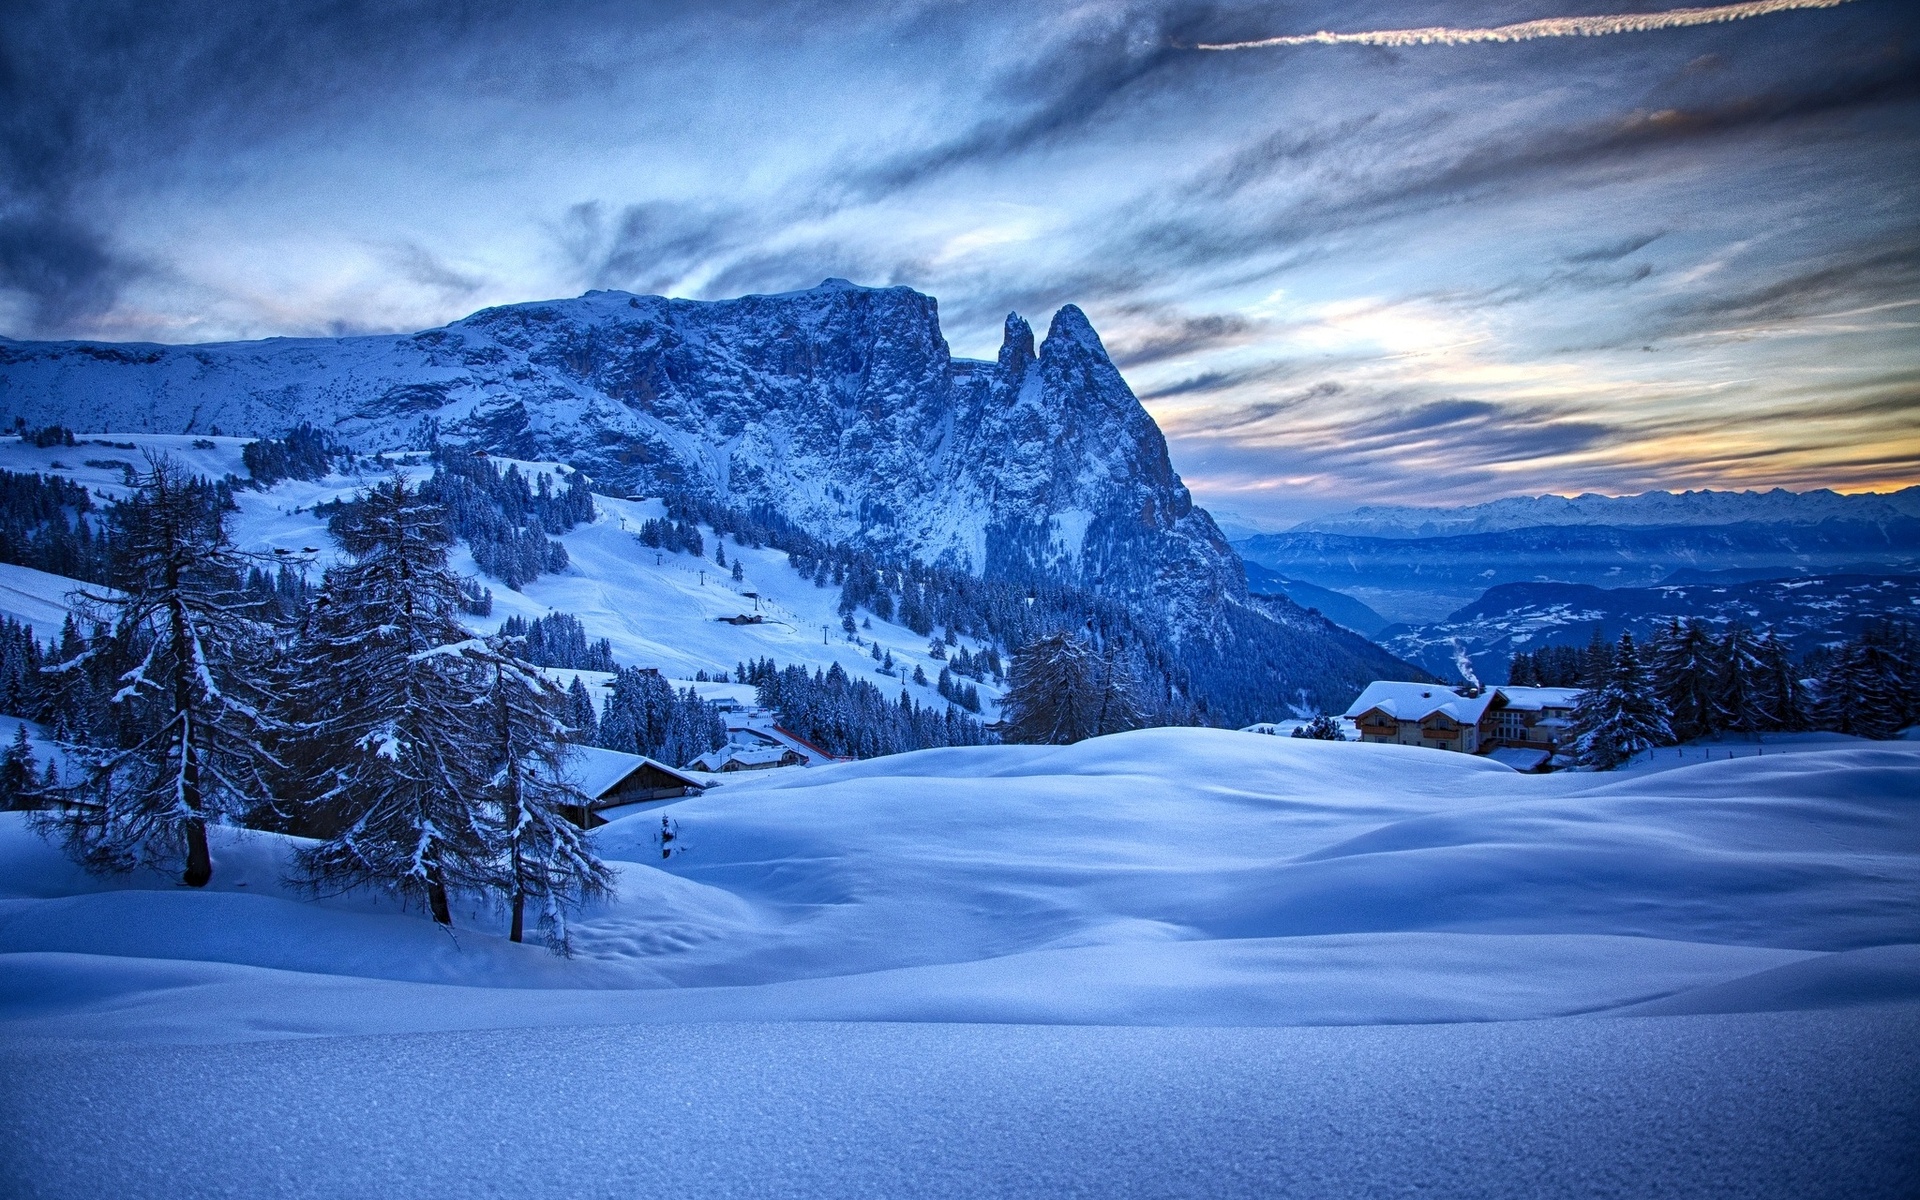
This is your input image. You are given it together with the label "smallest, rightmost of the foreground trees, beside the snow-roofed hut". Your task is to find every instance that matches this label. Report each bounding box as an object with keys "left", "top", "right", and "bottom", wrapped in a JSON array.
[{"left": 488, "top": 637, "right": 612, "bottom": 954}]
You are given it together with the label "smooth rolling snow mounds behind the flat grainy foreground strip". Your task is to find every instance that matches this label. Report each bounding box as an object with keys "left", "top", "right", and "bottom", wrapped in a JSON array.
[{"left": 0, "top": 730, "right": 1920, "bottom": 1039}]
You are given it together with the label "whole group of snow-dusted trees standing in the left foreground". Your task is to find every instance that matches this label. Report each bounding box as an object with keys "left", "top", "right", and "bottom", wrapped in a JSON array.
[{"left": 28, "top": 457, "right": 611, "bottom": 948}]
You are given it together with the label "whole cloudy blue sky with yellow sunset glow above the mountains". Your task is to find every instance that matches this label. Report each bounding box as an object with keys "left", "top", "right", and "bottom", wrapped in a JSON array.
[{"left": 0, "top": 0, "right": 1920, "bottom": 528}]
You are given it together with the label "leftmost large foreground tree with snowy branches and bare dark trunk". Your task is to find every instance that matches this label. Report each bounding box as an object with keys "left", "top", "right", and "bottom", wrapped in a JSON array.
[{"left": 40, "top": 455, "right": 275, "bottom": 887}]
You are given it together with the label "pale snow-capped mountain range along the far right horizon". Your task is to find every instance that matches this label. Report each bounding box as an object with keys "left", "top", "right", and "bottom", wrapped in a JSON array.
[{"left": 1290, "top": 486, "right": 1920, "bottom": 538}]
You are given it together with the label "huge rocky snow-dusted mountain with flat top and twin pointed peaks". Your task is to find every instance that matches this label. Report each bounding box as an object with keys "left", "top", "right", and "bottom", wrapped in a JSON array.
[{"left": 0, "top": 280, "right": 1411, "bottom": 724}]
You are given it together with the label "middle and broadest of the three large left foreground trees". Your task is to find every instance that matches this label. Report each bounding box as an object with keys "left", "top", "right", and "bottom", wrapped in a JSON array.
[{"left": 282, "top": 474, "right": 501, "bottom": 925}]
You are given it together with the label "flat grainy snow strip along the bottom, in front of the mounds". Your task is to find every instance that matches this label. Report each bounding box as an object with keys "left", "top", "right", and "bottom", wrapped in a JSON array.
[{"left": 0, "top": 1008, "right": 1920, "bottom": 1200}]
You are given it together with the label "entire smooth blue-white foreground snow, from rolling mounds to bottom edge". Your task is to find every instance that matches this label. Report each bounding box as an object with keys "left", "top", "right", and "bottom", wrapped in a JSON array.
[{"left": 0, "top": 730, "right": 1920, "bottom": 1198}]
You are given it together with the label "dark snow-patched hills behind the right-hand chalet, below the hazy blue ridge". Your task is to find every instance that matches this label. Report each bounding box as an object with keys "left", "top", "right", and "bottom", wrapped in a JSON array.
[{"left": 1379, "top": 574, "right": 1920, "bottom": 684}]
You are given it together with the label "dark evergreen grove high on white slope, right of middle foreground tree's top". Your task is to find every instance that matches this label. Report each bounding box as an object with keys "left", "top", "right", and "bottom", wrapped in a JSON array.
[{"left": 420, "top": 447, "right": 593, "bottom": 591}]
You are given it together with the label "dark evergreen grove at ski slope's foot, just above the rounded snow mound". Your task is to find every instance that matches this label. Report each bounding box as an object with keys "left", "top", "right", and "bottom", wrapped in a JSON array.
[{"left": 741, "top": 659, "right": 987, "bottom": 758}]
